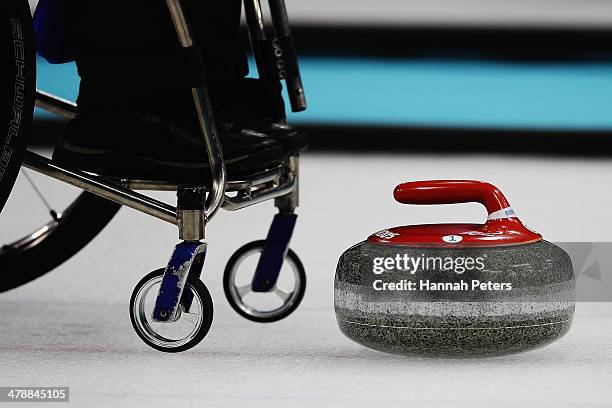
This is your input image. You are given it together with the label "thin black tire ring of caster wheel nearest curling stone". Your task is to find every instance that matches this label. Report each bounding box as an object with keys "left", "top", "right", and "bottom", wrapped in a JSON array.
[{"left": 223, "top": 240, "right": 306, "bottom": 323}]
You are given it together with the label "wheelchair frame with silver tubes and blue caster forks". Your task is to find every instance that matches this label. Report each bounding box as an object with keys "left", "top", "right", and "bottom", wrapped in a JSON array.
[{"left": 22, "top": 0, "right": 306, "bottom": 351}]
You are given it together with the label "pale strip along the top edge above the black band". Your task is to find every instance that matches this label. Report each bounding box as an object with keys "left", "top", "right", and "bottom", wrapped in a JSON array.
[{"left": 29, "top": 0, "right": 612, "bottom": 28}]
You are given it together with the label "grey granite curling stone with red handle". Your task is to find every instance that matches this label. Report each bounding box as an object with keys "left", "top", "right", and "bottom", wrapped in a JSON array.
[{"left": 334, "top": 180, "right": 575, "bottom": 357}]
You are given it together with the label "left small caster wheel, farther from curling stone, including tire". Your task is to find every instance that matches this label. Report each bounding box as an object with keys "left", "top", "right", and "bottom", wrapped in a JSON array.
[{"left": 130, "top": 269, "right": 213, "bottom": 353}]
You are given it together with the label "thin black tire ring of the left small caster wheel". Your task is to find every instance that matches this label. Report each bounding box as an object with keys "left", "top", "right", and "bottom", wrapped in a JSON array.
[{"left": 130, "top": 268, "right": 214, "bottom": 353}]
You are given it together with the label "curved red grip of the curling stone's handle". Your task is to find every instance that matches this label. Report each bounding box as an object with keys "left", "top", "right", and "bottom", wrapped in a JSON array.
[{"left": 393, "top": 180, "right": 516, "bottom": 219}]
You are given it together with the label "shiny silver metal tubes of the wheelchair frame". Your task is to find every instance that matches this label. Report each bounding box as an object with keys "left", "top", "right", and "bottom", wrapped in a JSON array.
[{"left": 23, "top": 0, "right": 298, "bottom": 225}]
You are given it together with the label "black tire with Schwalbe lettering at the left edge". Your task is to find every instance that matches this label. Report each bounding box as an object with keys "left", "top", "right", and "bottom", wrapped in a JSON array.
[{"left": 0, "top": 0, "right": 36, "bottom": 211}]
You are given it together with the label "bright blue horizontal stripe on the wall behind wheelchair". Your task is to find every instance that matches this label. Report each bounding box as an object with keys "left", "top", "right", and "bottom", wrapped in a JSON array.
[{"left": 37, "top": 57, "right": 612, "bottom": 130}]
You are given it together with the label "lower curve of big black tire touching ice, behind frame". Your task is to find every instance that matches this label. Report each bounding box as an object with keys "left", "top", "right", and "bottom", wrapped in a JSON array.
[{"left": 0, "top": 193, "right": 121, "bottom": 292}]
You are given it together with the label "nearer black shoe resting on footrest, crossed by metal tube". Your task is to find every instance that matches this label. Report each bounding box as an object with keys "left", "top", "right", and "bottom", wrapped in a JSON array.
[{"left": 53, "top": 109, "right": 286, "bottom": 181}]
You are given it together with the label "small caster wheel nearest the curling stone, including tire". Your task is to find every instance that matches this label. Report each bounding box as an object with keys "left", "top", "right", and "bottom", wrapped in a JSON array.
[{"left": 223, "top": 240, "right": 306, "bottom": 323}]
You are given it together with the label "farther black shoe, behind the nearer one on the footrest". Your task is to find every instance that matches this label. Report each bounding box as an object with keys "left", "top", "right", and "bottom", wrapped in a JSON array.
[{"left": 210, "top": 78, "right": 308, "bottom": 156}]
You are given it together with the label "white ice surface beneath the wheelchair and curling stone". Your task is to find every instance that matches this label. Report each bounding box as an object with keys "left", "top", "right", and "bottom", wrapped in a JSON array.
[{"left": 0, "top": 154, "right": 612, "bottom": 408}]
